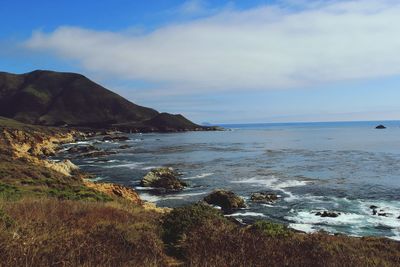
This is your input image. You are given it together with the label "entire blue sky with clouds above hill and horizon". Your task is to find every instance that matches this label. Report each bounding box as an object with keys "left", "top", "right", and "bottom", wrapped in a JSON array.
[{"left": 0, "top": 0, "right": 400, "bottom": 123}]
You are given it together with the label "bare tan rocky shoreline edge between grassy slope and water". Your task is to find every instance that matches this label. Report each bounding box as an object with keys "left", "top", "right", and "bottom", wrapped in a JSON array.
[{"left": 0, "top": 125, "right": 169, "bottom": 212}]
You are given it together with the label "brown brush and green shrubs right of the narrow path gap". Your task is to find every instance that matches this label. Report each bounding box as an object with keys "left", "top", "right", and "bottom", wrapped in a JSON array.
[{"left": 164, "top": 205, "right": 400, "bottom": 266}]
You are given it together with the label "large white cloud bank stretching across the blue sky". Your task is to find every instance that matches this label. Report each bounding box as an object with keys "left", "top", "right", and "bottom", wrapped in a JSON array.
[{"left": 26, "top": 0, "right": 400, "bottom": 91}]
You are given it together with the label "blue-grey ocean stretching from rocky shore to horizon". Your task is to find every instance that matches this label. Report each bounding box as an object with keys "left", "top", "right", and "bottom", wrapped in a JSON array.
[{"left": 61, "top": 121, "right": 400, "bottom": 240}]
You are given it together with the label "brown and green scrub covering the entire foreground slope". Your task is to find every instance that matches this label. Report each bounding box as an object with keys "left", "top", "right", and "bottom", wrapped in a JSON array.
[{"left": 0, "top": 118, "right": 400, "bottom": 266}]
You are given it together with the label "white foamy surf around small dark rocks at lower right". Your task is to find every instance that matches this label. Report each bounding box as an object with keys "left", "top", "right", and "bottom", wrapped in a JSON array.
[{"left": 284, "top": 199, "right": 400, "bottom": 240}]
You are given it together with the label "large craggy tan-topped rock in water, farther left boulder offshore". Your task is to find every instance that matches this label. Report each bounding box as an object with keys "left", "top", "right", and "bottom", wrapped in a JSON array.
[{"left": 140, "top": 167, "right": 187, "bottom": 192}]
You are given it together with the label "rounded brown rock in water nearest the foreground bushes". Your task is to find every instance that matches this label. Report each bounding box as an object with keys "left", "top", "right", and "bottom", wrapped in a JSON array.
[{"left": 204, "top": 189, "right": 246, "bottom": 212}]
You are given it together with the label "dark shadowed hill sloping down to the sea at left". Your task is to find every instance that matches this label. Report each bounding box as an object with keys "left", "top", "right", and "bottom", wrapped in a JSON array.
[{"left": 0, "top": 70, "right": 206, "bottom": 130}]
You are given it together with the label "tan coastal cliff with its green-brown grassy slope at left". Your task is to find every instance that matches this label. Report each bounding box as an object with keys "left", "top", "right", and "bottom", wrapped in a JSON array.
[{"left": 0, "top": 118, "right": 145, "bottom": 208}]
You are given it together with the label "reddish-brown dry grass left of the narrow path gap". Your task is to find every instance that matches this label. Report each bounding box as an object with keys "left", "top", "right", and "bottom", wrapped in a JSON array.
[{"left": 0, "top": 199, "right": 166, "bottom": 266}]
